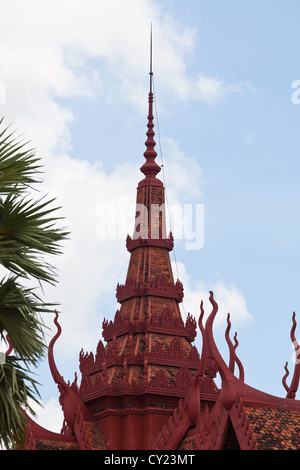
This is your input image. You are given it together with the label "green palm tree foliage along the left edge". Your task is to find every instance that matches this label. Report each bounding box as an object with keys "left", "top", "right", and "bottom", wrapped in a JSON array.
[{"left": 0, "top": 119, "right": 68, "bottom": 448}]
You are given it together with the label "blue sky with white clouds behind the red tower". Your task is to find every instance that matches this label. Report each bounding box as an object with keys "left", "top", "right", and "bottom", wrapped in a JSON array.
[{"left": 0, "top": 0, "right": 300, "bottom": 427}]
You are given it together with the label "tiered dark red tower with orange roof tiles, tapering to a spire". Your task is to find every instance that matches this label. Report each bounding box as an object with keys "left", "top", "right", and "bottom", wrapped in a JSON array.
[{"left": 79, "top": 64, "right": 218, "bottom": 449}]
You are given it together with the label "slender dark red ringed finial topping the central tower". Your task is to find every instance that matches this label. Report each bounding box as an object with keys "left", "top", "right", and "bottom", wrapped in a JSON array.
[{"left": 141, "top": 24, "right": 160, "bottom": 183}]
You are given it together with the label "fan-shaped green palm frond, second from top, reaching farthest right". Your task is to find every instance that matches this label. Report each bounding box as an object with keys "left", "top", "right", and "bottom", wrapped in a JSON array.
[{"left": 0, "top": 194, "right": 68, "bottom": 283}]
